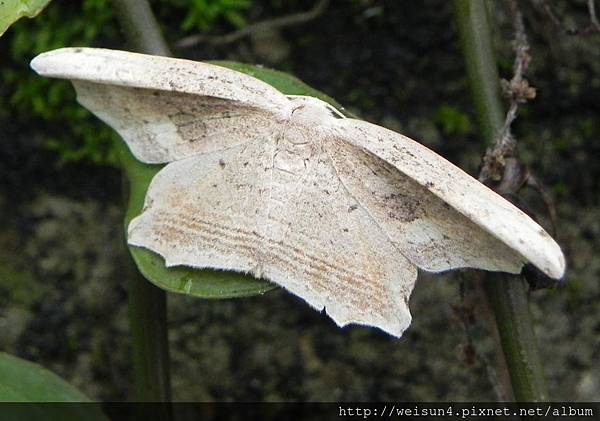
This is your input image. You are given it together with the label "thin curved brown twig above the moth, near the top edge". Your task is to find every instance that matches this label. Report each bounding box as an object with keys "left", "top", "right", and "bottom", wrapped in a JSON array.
[{"left": 175, "top": 0, "right": 329, "bottom": 48}]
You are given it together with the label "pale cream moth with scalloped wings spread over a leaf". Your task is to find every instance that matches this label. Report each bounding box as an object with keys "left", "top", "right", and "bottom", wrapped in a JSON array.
[{"left": 31, "top": 48, "right": 565, "bottom": 337}]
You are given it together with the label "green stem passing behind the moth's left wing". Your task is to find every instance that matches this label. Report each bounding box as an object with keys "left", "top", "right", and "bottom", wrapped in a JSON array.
[{"left": 112, "top": 0, "right": 171, "bottom": 402}]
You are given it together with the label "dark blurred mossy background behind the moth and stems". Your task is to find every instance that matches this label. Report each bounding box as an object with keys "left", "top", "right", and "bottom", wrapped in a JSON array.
[{"left": 0, "top": 0, "right": 600, "bottom": 400}]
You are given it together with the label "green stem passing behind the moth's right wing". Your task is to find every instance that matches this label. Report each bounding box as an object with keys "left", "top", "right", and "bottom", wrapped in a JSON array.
[{"left": 454, "top": 0, "right": 548, "bottom": 402}]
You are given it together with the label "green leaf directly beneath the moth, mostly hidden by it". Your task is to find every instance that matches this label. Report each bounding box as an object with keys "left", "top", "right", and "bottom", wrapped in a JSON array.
[{"left": 119, "top": 61, "right": 342, "bottom": 298}]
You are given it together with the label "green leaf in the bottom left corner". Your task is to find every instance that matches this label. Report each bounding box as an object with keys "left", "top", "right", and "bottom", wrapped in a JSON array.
[{"left": 0, "top": 352, "right": 106, "bottom": 420}]
